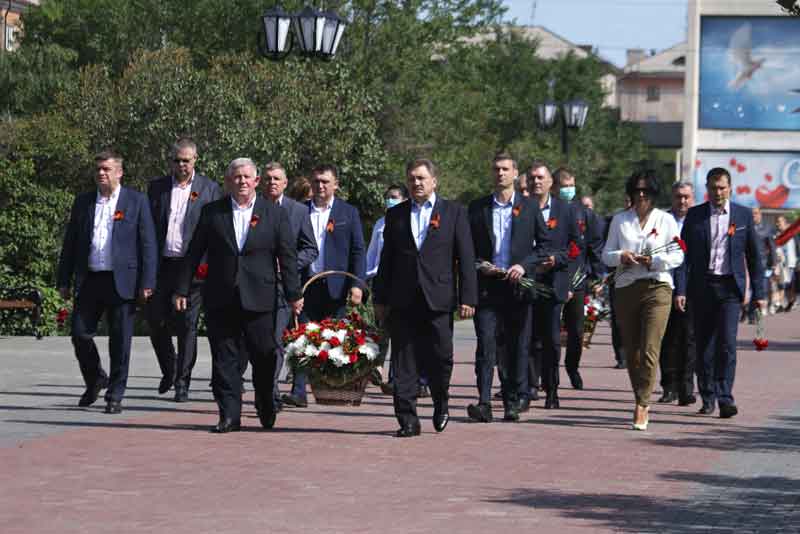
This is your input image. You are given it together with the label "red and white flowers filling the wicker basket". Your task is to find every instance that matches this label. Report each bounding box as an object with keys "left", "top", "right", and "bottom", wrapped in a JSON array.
[{"left": 283, "top": 311, "right": 381, "bottom": 387}]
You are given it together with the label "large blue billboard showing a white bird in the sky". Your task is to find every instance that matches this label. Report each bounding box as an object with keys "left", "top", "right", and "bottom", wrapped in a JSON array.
[{"left": 698, "top": 16, "right": 800, "bottom": 131}]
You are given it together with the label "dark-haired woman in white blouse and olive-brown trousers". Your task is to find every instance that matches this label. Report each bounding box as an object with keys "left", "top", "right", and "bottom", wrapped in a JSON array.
[{"left": 603, "top": 171, "right": 683, "bottom": 430}]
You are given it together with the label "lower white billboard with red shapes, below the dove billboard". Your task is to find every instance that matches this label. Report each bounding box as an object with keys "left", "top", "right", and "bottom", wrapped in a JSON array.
[{"left": 694, "top": 151, "right": 800, "bottom": 209}]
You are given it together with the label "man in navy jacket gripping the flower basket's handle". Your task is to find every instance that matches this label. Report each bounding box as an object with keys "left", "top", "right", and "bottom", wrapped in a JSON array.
[{"left": 281, "top": 165, "right": 367, "bottom": 408}]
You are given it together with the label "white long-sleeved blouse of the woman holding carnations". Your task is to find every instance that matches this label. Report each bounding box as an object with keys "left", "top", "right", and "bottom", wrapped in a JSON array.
[{"left": 603, "top": 208, "right": 683, "bottom": 287}]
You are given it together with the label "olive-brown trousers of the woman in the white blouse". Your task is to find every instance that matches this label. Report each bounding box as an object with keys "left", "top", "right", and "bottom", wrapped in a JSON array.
[{"left": 614, "top": 279, "right": 672, "bottom": 406}]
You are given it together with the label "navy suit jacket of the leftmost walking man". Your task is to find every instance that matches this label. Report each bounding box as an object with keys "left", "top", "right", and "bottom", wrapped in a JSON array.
[{"left": 58, "top": 187, "right": 158, "bottom": 300}]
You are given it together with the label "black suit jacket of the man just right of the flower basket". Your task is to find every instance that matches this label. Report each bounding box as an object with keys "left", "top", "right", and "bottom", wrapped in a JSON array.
[{"left": 374, "top": 196, "right": 478, "bottom": 312}]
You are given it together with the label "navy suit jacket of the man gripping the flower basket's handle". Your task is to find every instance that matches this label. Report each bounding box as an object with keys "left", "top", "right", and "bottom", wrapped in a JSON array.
[{"left": 306, "top": 198, "right": 367, "bottom": 300}]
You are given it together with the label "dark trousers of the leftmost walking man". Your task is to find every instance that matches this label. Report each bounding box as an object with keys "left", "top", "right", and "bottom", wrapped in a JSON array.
[{"left": 72, "top": 271, "right": 136, "bottom": 402}]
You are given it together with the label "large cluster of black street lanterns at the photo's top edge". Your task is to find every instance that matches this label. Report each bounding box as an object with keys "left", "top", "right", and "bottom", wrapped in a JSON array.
[{"left": 259, "top": 6, "right": 347, "bottom": 59}]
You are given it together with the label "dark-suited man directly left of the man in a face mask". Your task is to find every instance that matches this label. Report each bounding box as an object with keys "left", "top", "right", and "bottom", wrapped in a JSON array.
[{"left": 528, "top": 160, "right": 580, "bottom": 409}]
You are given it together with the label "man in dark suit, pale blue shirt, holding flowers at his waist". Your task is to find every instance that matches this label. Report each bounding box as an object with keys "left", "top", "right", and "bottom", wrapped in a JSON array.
[{"left": 467, "top": 154, "right": 549, "bottom": 423}]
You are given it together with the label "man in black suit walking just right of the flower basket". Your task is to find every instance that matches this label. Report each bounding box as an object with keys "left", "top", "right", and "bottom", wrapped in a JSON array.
[{"left": 374, "top": 159, "right": 478, "bottom": 438}]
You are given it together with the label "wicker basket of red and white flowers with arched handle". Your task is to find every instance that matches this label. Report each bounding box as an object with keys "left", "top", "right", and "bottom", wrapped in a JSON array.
[{"left": 283, "top": 271, "right": 381, "bottom": 406}]
